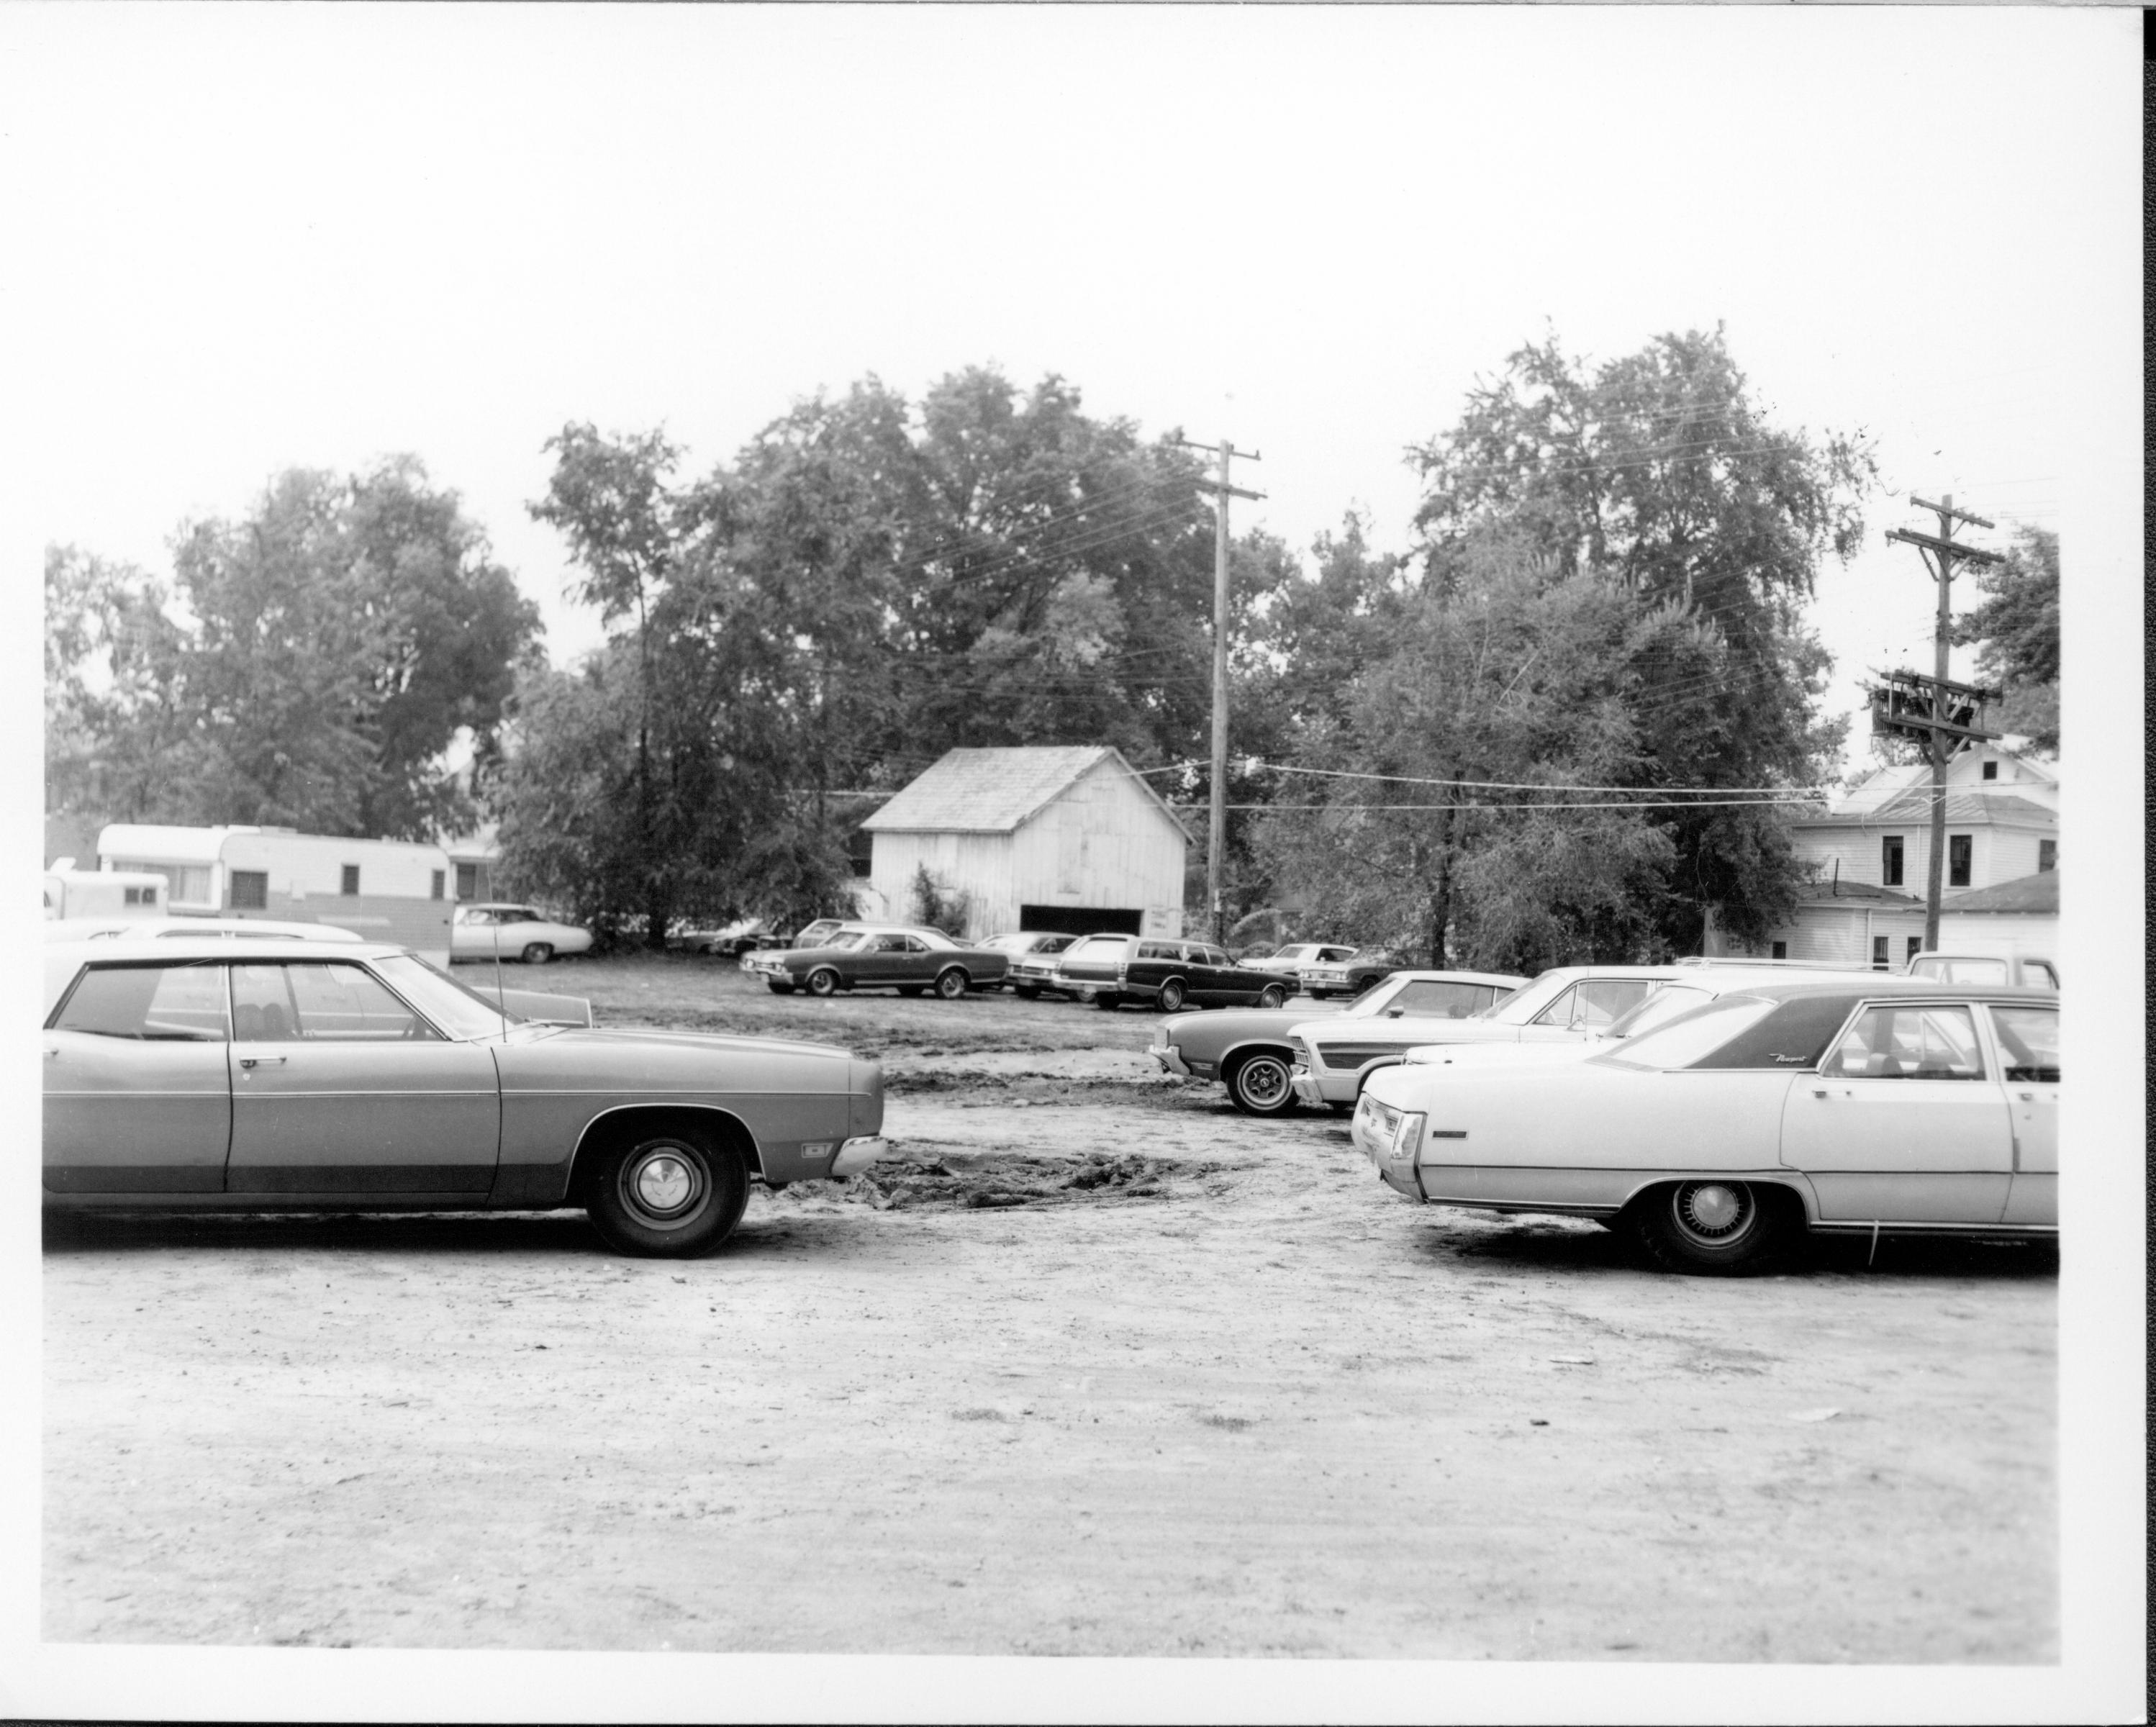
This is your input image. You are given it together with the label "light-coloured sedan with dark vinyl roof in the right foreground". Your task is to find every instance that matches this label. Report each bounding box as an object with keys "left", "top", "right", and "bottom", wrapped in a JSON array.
[{"left": 1354, "top": 972, "right": 2059, "bottom": 1274}]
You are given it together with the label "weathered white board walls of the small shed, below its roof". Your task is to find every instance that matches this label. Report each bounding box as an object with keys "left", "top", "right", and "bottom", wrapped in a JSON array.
[{"left": 869, "top": 761, "right": 1190, "bottom": 938}]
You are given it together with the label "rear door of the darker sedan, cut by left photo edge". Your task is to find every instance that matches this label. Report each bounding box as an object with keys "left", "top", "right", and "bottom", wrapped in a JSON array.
[{"left": 43, "top": 959, "right": 233, "bottom": 1192}]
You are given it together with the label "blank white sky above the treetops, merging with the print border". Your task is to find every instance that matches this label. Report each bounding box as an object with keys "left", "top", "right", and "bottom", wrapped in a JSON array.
[{"left": 0, "top": 6, "right": 2139, "bottom": 780}]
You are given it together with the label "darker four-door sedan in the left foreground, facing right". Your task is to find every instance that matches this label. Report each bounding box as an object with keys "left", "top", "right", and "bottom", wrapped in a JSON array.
[{"left": 43, "top": 938, "right": 884, "bottom": 1255}]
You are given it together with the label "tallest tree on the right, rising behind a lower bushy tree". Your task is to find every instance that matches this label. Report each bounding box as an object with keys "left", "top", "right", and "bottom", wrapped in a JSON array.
[{"left": 1414, "top": 330, "right": 1874, "bottom": 951}]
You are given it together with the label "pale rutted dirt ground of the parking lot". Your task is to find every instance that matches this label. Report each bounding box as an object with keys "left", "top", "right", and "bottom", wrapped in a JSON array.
[{"left": 43, "top": 957, "right": 2059, "bottom": 1662}]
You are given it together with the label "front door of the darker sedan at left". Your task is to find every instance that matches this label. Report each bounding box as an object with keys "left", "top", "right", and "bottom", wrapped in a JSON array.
[{"left": 225, "top": 959, "right": 500, "bottom": 1195}]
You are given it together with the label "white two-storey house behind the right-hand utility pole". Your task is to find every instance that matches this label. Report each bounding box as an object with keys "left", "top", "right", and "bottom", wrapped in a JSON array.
[{"left": 1708, "top": 746, "right": 2059, "bottom": 970}]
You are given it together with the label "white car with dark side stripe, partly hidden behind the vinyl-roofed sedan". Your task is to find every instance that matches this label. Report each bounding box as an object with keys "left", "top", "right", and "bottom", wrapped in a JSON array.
[{"left": 1287, "top": 966, "right": 1677, "bottom": 1108}]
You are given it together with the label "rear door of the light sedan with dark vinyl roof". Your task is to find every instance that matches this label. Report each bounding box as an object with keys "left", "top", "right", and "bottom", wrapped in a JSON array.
[{"left": 1781, "top": 1002, "right": 2014, "bottom": 1225}]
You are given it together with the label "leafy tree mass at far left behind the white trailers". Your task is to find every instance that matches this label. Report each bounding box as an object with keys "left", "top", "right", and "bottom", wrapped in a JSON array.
[{"left": 45, "top": 457, "right": 539, "bottom": 839}]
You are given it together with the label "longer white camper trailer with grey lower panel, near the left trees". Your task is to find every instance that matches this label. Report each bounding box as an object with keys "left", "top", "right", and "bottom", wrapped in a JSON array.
[{"left": 97, "top": 824, "right": 453, "bottom": 966}]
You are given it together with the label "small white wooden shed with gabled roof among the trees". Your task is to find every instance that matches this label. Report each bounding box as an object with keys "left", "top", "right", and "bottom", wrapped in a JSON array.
[{"left": 862, "top": 746, "right": 1190, "bottom": 940}]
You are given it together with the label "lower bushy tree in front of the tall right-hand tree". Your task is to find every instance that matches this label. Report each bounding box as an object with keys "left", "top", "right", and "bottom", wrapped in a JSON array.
[{"left": 1259, "top": 537, "right": 1688, "bottom": 970}]
